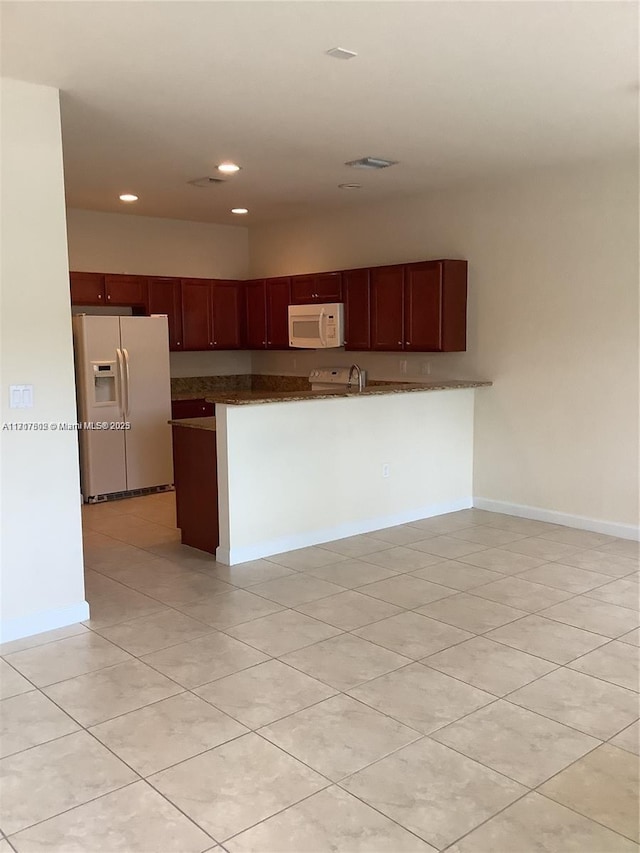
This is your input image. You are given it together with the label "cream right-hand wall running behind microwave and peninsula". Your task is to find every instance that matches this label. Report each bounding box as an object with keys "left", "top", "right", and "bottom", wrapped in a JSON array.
[{"left": 250, "top": 161, "right": 638, "bottom": 535}]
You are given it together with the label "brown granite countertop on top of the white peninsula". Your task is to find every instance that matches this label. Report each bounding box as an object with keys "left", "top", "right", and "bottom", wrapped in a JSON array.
[{"left": 202, "top": 379, "right": 493, "bottom": 406}]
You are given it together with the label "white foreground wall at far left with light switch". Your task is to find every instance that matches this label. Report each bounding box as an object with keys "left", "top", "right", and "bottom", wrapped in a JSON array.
[{"left": 0, "top": 79, "right": 89, "bottom": 641}]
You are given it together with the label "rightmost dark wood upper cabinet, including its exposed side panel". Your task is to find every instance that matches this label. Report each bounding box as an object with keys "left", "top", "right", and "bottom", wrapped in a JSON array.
[{"left": 404, "top": 261, "right": 467, "bottom": 352}]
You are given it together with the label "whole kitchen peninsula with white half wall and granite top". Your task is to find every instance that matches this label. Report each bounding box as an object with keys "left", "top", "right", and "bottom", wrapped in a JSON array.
[{"left": 171, "top": 380, "right": 491, "bottom": 565}]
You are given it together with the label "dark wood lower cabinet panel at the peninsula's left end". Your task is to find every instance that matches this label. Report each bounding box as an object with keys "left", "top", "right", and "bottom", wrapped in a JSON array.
[{"left": 172, "top": 425, "right": 219, "bottom": 554}]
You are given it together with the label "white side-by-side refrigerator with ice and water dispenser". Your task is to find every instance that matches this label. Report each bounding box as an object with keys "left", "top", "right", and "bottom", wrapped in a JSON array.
[{"left": 73, "top": 314, "right": 173, "bottom": 503}]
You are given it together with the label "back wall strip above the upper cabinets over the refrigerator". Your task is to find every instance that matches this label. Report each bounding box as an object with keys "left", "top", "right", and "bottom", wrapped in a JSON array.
[{"left": 67, "top": 209, "right": 248, "bottom": 278}]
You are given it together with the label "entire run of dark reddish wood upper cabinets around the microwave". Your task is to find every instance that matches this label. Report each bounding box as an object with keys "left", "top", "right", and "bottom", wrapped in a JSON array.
[{"left": 70, "top": 260, "right": 467, "bottom": 352}]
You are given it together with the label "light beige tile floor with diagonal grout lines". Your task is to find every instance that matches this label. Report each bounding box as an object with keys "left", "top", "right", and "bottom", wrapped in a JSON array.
[{"left": 0, "top": 494, "right": 640, "bottom": 853}]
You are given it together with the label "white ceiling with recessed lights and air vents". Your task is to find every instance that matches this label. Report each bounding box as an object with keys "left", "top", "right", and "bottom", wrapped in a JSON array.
[{"left": 2, "top": 0, "right": 638, "bottom": 225}]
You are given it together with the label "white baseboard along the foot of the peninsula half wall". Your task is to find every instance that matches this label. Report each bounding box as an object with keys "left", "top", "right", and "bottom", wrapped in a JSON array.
[{"left": 216, "top": 497, "right": 473, "bottom": 566}]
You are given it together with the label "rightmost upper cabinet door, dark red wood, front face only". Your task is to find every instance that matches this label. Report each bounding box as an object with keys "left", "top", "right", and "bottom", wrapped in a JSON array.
[{"left": 404, "top": 263, "right": 442, "bottom": 352}]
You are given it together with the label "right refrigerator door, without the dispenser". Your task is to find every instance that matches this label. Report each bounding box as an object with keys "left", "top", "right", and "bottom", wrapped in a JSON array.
[{"left": 118, "top": 317, "right": 173, "bottom": 489}]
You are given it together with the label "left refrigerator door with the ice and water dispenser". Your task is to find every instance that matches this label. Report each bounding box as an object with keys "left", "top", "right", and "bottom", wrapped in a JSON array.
[{"left": 73, "top": 315, "right": 127, "bottom": 500}]
